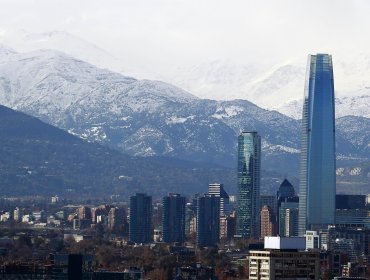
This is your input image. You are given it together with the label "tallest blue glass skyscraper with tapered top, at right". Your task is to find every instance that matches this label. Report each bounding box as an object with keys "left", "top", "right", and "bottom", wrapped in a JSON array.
[{"left": 299, "top": 54, "right": 336, "bottom": 236}]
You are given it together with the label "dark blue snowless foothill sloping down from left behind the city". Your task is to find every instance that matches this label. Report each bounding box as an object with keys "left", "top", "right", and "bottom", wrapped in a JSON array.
[{"left": 0, "top": 105, "right": 235, "bottom": 199}]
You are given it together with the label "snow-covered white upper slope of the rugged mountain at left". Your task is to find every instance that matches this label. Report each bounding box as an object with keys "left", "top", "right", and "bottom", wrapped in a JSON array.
[{"left": 0, "top": 47, "right": 196, "bottom": 122}]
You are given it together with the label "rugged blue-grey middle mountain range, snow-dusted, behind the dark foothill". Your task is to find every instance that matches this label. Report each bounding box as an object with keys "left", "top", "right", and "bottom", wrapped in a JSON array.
[{"left": 0, "top": 44, "right": 370, "bottom": 196}]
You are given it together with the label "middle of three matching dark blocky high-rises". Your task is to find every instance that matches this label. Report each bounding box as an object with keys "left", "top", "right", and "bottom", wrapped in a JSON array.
[{"left": 162, "top": 193, "right": 185, "bottom": 243}]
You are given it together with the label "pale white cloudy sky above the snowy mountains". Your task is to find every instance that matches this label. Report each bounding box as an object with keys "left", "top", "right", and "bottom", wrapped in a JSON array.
[{"left": 0, "top": 0, "right": 370, "bottom": 74}]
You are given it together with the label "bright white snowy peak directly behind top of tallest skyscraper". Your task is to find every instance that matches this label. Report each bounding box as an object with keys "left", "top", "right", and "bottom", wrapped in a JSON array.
[{"left": 164, "top": 57, "right": 370, "bottom": 119}]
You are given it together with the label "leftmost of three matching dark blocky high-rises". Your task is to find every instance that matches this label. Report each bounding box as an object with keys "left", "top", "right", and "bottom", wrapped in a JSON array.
[{"left": 129, "top": 193, "right": 152, "bottom": 243}]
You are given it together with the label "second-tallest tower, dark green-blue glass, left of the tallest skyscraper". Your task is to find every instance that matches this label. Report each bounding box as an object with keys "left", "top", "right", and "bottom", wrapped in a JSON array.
[{"left": 237, "top": 132, "right": 261, "bottom": 238}]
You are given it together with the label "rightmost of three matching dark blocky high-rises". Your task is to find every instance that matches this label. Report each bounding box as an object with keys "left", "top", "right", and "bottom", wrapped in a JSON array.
[{"left": 196, "top": 194, "right": 220, "bottom": 247}]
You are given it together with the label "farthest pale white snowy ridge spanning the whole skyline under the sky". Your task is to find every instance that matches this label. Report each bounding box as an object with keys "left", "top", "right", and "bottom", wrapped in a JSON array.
[{"left": 0, "top": 30, "right": 370, "bottom": 119}]
